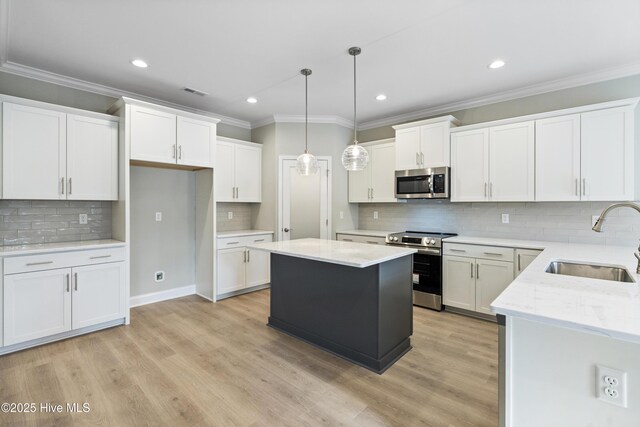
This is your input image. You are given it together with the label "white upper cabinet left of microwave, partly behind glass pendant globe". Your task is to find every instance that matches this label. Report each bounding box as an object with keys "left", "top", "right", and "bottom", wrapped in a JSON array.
[{"left": 349, "top": 140, "right": 397, "bottom": 203}]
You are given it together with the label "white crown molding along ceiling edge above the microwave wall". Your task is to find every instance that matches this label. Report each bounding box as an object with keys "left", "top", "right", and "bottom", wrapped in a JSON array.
[{"left": 358, "top": 62, "right": 640, "bottom": 130}]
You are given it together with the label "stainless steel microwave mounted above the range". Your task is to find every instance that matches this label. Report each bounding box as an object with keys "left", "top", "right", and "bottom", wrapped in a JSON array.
[{"left": 396, "top": 167, "right": 449, "bottom": 199}]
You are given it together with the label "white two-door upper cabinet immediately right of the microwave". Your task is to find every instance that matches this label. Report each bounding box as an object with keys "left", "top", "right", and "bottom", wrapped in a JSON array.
[{"left": 451, "top": 121, "right": 535, "bottom": 202}]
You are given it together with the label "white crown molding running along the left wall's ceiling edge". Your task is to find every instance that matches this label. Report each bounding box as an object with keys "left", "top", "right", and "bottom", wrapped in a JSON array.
[{"left": 0, "top": 60, "right": 251, "bottom": 129}]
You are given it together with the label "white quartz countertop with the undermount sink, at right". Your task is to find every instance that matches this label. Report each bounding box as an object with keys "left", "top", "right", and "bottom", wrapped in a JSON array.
[{"left": 484, "top": 238, "right": 640, "bottom": 343}]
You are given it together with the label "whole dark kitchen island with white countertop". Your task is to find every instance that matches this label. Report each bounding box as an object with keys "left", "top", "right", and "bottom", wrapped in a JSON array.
[{"left": 245, "top": 239, "right": 416, "bottom": 374}]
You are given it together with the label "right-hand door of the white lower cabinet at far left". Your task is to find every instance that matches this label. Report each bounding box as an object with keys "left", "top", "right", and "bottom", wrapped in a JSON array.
[{"left": 71, "top": 262, "right": 128, "bottom": 329}]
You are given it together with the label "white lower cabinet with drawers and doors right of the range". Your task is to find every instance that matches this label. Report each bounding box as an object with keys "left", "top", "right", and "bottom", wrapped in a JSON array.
[{"left": 442, "top": 244, "right": 514, "bottom": 315}]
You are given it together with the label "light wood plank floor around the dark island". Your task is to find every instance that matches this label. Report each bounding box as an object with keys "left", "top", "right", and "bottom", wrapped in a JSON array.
[{"left": 0, "top": 290, "right": 498, "bottom": 427}]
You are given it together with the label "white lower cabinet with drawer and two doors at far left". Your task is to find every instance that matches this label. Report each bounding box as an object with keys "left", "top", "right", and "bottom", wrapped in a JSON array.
[{"left": 2, "top": 248, "right": 128, "bottom": 346}]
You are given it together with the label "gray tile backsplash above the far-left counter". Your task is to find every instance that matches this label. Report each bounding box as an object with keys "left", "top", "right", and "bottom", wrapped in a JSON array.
[{"left": 0, "top": 200, "right": 111, "bottom": 246}]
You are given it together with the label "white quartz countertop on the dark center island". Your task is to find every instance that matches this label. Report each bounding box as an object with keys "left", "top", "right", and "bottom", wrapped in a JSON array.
[{"left": 247, "top": 239, "right": 417, "bottom": 268}]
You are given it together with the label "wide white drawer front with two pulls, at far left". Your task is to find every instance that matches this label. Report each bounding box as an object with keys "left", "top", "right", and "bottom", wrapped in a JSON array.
[{"left": 4, "top": 247, "right": 125, "bottom": 274}]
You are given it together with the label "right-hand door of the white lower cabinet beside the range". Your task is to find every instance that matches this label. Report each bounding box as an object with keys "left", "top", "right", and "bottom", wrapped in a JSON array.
[{"left": 476, "top": 259, "right": 513, "bottom": 314}]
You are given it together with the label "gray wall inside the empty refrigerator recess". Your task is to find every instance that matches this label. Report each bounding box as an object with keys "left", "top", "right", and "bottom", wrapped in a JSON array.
[{"left": 131, "top": 166, "right": 195, "bottom": 296}]
